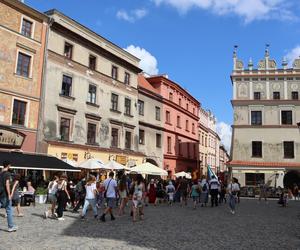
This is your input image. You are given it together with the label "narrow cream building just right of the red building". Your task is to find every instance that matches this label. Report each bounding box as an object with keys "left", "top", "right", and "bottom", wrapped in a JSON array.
[{"left": 199, "top": 107, "right": 221, "bottom": 174}]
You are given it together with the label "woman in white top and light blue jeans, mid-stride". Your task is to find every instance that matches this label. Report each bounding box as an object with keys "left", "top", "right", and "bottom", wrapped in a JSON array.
[{"left": 81, "top": 175, "right": 98, "bottom": 219}]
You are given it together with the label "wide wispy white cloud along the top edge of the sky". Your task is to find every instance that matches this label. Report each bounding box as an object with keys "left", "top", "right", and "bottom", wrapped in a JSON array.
[{"left": 152, "top": 0, "right": 296, "bottom": 23}]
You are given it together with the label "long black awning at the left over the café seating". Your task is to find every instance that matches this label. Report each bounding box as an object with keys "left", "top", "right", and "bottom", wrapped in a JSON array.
[{"left": 0, "top": 151, "right": 80, "bottom": 172}]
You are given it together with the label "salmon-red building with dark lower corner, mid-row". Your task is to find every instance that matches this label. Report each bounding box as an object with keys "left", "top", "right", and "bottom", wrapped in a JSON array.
[{"left": 147, "top": 75, "right": 200, "bottom": 178}]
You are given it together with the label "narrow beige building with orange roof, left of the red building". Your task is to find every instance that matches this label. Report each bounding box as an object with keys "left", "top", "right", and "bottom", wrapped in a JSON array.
[{"left": 138, "top": 74, "right": 164, "bottom": 168}]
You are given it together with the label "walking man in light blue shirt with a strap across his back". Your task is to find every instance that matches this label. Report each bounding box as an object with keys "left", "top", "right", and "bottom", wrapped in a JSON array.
[{"left": 100, "top": 172, "right": 118, "bottom": 222}]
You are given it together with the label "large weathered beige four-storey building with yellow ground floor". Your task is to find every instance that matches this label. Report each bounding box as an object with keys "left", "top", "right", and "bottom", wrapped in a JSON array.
[{"left": 41, "top": 10, "right": 144, "bottom": 166}]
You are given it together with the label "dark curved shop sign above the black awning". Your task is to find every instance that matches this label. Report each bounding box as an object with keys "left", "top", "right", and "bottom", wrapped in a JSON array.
[{"left": 0, "top": 125, "right": 26, "bottom": 149}]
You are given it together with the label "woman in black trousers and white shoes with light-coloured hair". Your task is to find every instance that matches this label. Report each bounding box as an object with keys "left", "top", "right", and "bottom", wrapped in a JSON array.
[{"left": 56, "top": 175, "right": 70, "bottom": 220}]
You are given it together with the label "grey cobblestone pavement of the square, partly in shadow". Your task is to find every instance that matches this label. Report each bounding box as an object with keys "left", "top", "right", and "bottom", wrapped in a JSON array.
[{"left": 0, "top": 200, "right": 300, "bottom": 250}]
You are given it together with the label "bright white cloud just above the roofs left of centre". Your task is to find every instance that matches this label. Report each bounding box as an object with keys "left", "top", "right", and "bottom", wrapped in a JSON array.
[{"left": 125, "top": 45, "right": 158, "bottom": 75}]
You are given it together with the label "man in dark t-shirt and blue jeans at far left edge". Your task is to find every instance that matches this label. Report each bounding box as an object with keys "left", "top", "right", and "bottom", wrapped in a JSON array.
[{"left": 0, "top": 161, "right": 18, "bottom": 232}]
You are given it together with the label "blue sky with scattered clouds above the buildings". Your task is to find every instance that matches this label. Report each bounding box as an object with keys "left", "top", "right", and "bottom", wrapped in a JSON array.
[{"left": 25, "top": 0, "right": 300, "bottom": 149}]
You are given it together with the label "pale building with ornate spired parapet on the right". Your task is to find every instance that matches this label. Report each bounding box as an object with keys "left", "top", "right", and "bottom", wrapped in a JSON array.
[{"left": 230, "top": 47, "right": 300, "bottom": 186}]
